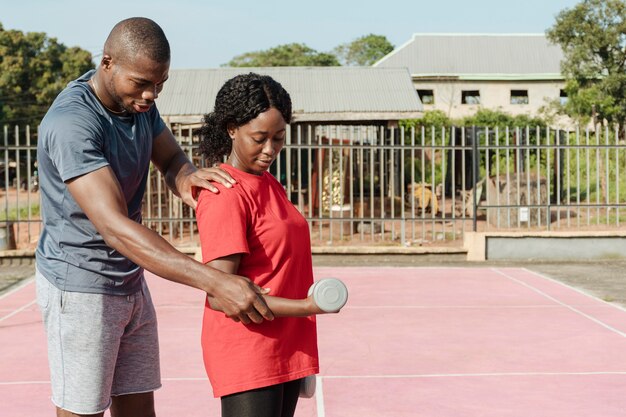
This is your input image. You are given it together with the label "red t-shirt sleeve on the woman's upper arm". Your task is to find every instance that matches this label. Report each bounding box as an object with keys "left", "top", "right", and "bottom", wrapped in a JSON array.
[{"left": 196, "top": 185, "right": 250, "bottom": 263}]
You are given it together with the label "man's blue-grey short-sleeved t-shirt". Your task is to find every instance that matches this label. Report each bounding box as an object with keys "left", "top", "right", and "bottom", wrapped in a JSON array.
[{"left": 36, "top": 70, "right": 165, "bottom": 295}]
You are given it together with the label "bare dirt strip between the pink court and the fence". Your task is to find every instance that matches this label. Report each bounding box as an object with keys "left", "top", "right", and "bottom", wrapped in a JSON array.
[{"left": 0, "top": 255, "right": 626, "bottom": 308}]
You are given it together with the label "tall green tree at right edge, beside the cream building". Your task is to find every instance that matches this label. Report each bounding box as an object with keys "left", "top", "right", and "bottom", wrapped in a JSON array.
[{"left": 546, "top": 0, "right": 626, "bottom": 132}]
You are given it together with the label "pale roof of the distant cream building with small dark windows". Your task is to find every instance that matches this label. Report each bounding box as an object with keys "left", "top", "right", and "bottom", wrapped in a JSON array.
[{"left": 374, "top": 34, "right": 563, "bottom": 79}]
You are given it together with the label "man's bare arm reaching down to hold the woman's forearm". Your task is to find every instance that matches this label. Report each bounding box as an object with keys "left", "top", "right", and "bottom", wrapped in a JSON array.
[{"left": 67, "top": 166, "right": 273, "bottom": 323}]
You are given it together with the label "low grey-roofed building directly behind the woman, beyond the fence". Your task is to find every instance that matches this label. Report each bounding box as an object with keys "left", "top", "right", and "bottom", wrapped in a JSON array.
[{"left": 153, "top": 67, "right": 423, "bottom": 216}]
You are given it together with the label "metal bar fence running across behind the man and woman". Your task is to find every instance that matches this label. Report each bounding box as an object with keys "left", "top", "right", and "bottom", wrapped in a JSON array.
[{"left": 0, "top": 125, "right": 626, "bottom": 248}]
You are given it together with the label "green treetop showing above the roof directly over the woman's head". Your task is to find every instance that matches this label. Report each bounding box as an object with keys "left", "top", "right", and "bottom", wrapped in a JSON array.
[{"left": 226, "top": 43, "right": 339, "bottom": 67}]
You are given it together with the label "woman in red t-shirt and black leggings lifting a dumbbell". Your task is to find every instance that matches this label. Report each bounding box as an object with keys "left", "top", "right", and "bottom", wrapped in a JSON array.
[{"left": 197, "top": 73, "right": 323, "bottom": 417}]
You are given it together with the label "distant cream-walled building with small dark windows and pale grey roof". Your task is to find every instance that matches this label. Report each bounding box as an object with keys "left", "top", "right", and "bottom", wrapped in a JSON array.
[{"left": 374, "top": 34, "right": 566, "bottom": 119}]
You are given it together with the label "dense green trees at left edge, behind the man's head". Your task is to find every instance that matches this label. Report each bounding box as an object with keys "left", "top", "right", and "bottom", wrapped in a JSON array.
[{"left": 0, "top": 24, "right": 94, "bottom": 126}]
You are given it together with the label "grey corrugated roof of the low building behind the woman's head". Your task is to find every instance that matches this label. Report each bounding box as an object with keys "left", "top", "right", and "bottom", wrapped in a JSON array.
[{"left": 157, "top": 67, "right": 423, "bottom": 120}]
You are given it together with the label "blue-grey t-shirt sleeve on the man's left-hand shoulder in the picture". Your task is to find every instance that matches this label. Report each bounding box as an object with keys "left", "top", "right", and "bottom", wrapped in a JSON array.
[{"left": 42, "top": 108, "right": 109, "bottom": 182}]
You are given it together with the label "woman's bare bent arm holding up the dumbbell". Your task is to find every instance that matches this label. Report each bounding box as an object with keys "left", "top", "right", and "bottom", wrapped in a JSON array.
[{"left": 207, "top": 254, "right": 324, "bottom": 317}]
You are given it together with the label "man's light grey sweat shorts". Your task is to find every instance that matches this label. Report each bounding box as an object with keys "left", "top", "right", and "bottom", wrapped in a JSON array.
[{"left": 36, "top": 271, "right": 161, "bottom": 414}]
